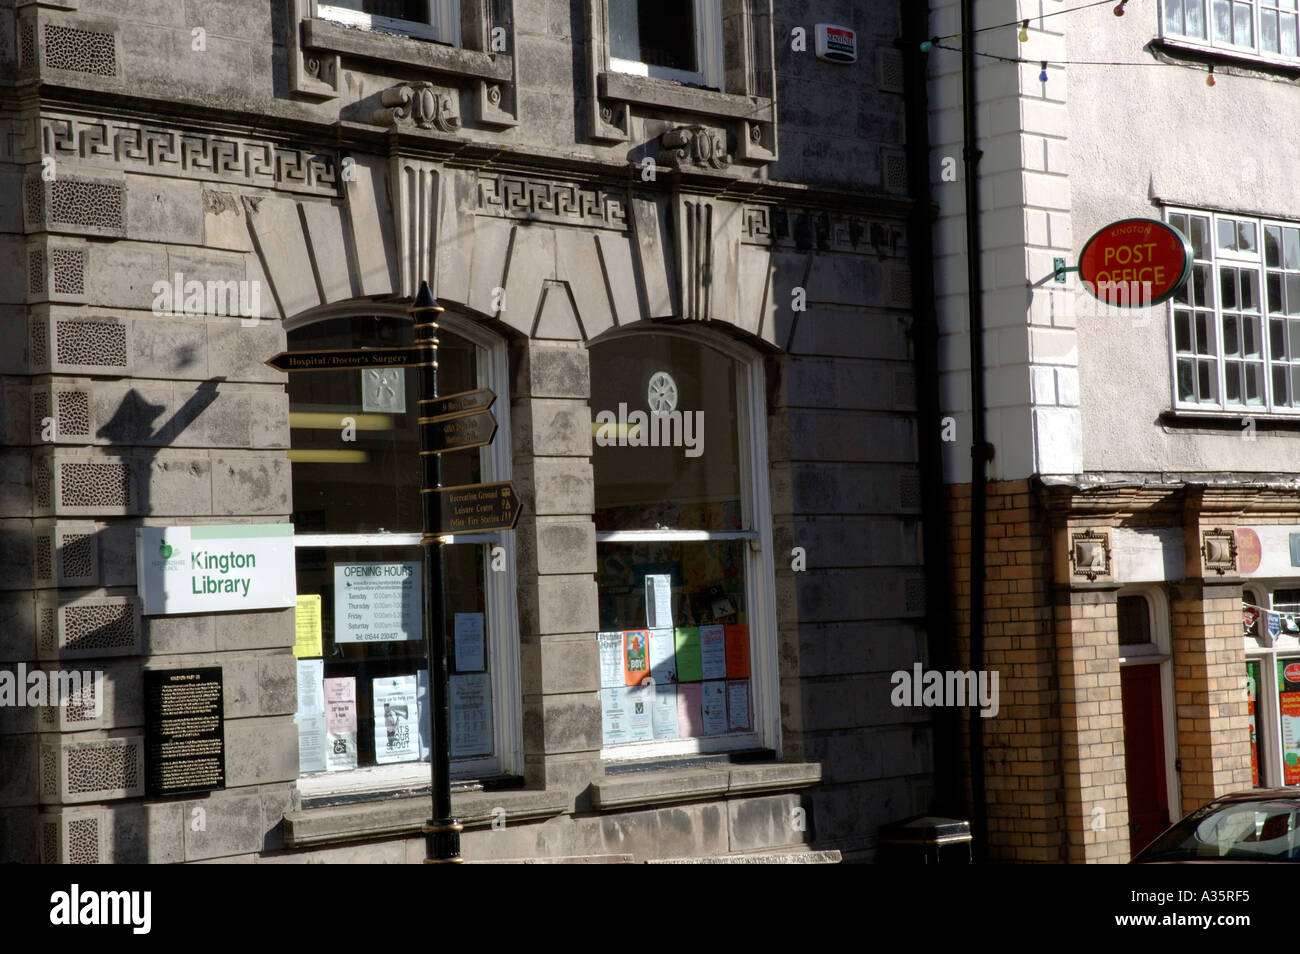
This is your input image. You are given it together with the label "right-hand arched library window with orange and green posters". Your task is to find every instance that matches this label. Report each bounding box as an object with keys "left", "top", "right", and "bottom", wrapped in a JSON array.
[{"left": 592, "top": 330, "right": 776, "bottom": 758}]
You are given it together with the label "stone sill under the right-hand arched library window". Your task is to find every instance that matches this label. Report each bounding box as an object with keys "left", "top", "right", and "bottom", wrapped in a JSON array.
[{"left": 592, "top": 762, "right": 822, "bottom": 811}]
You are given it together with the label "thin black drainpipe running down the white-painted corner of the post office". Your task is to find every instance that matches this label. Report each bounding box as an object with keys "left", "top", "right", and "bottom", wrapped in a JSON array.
[{"left": 962, "top": 0, "right": 992, "bottom": 862}]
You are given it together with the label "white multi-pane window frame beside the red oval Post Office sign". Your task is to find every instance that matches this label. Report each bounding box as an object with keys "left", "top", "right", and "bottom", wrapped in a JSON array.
[{"left": 1165, "top": 205, "right": 1300, "bottom": 417}]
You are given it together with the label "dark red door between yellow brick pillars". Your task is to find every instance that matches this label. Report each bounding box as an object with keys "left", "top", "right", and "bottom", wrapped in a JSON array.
[{"left": 1119, "top": 664, "right": 1169, "bottom": 854}]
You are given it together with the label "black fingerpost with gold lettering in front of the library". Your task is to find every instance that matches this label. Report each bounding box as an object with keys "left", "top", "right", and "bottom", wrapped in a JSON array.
[{"left": 267, "top": 282, "right": 521, "bottom": 864}]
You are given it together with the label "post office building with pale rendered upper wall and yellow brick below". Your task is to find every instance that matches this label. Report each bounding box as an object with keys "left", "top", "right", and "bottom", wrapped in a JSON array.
[{"left": 931, "top": 0, "right": 1300, "bottom": 863}]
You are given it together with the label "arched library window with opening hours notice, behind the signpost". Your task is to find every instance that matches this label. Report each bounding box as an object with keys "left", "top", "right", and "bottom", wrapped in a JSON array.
[{"left": 287, "top": 312, "right": 519, "bottom": 792}]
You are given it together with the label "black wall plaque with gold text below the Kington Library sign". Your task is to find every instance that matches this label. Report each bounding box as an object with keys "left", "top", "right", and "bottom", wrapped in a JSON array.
[{"left": 144, "top": 665, "right": 226, "bottom": 797}]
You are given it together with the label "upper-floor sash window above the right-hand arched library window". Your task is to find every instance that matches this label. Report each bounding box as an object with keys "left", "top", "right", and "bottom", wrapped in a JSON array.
[{"left": 608, "top": 0, "right": 723, "bottom": 90}]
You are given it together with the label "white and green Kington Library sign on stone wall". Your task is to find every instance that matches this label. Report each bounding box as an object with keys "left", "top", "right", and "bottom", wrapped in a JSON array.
[{"left": 135, "top": 524, "right": 298, "bottom": 616}]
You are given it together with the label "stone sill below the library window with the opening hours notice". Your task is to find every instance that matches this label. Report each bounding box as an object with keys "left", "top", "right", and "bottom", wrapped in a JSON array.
[{"left": 285, "top": 792, "right": 572, "bottom": 849}]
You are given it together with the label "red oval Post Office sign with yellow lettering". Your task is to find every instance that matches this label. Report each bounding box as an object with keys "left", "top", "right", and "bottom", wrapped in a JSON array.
[{"left": 1079, "top": 218, "right": 1192, "bottom": 308}]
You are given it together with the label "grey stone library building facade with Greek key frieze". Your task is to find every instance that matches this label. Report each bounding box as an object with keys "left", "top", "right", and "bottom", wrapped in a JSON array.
[{"left": 0, "top": 0, "right": 932, "bottom": 863}]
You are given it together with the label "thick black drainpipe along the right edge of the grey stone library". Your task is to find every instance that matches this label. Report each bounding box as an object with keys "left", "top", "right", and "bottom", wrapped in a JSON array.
[{"left": 898, "top": 0, "right": 961, "bottom": 815}]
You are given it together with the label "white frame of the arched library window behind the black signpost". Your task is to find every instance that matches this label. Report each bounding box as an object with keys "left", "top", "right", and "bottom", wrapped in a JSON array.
[{"left": 285, "top": 303, "right": 524, "bottom": 797}]
